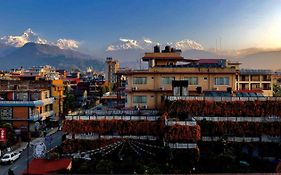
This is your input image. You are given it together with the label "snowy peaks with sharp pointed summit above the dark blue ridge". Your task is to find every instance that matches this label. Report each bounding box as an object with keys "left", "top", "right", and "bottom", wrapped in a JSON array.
[{"left": 0, "top": 28, "right": 79, "bottom": 50}]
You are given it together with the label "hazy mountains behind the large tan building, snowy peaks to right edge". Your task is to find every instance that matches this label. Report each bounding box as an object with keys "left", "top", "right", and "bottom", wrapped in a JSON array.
[{"left": 103, "top": 38, "right": 281, "bottom": 70}]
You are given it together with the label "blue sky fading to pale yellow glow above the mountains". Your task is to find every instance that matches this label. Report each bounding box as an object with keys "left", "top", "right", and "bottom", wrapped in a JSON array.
[{"left": 0, "top": 0, "right": 281, "bottom": 51}]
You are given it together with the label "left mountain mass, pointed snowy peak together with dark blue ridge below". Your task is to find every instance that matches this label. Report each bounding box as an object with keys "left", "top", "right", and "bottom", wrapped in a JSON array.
[{"left": 0, "top": 29, "right": 104, "bottom": 71}]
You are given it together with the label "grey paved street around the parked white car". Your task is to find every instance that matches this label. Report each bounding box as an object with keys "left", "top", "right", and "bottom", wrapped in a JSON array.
[{"left": 0, "top": 131, "right": 63, "bottom": 175}]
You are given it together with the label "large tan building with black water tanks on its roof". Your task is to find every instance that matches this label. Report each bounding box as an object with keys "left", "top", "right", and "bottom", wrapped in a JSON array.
[{"left": 118, "top": 46, "right": 239, "bottom": 108}]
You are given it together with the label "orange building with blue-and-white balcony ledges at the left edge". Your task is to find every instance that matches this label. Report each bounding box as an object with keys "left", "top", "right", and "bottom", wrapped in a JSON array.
[{"left": 0, "top": 90, "right": 55, "bottom": 131}]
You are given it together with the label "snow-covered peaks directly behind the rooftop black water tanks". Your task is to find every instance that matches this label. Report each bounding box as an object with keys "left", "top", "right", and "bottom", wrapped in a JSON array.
[{"left": 106, "top": 38, "right": 204, "bottom": 52}]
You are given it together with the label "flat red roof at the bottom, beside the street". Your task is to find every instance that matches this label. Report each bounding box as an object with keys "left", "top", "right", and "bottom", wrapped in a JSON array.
[{"left": 23, "top": 159, "right": 72, "bottom": 174}]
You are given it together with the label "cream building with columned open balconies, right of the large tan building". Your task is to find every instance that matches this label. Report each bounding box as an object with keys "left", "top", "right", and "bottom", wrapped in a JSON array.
[{"left": 236, "top": 69, "right": 273, "bottom": 96}]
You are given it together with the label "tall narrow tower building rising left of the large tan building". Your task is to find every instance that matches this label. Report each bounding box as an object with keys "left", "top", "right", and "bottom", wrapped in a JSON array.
[{"left": 105, "top": 57, "right": 119, "bottom": 83}]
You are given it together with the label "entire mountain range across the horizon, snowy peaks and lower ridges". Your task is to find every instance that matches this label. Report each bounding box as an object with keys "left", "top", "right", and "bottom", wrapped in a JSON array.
[{"left": 0, "top": 29, "right": 281, "bottom": 71}]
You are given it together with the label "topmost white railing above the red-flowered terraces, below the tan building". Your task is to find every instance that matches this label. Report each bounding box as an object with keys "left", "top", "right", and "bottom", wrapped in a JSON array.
[{"left": 166, "top": 96, "right": 281, "bottom": 101}]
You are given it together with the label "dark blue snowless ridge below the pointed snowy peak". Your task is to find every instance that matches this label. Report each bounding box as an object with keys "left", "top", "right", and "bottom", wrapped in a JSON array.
[{"left": 0, "top": 43, "right": 104, "bottom": 71}]
